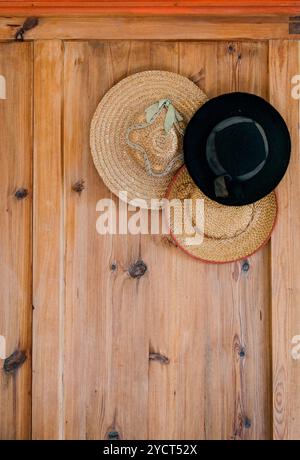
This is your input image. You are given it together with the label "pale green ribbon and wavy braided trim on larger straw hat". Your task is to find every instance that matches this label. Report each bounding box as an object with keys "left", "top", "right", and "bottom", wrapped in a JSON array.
[{"left": 126, "top": 99, "right": 183, "bottom": 177}]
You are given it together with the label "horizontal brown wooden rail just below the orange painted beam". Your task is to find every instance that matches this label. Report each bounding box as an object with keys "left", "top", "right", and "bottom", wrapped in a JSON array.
[{"left": 0, "top": 16, "right": 297, "bottom": 40}]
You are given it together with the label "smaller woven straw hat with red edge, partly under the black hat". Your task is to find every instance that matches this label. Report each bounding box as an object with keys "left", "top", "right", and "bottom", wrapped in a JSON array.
[{"left": 167, "top": 166, "right": 277, "bottom": 263}]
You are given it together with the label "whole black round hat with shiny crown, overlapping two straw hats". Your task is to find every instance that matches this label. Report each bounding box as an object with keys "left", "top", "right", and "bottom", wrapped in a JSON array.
[{"left": 184, "top": 92, "right": 291, "bottom": 206}]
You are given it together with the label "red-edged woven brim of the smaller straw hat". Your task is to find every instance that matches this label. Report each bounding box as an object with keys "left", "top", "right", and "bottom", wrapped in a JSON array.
[{"left": 166, "top": 166, "right": 278, "bottom": 263}]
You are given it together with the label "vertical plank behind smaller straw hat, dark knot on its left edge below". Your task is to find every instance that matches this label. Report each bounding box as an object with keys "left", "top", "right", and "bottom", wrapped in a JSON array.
[{"left": 146, "top": 42, "right": 203, "bottom": 439}]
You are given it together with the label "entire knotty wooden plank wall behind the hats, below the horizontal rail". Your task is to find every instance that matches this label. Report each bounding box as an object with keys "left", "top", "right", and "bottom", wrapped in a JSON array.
[{"left": 0, "top": 16, "right": 300, "bottom": 439}]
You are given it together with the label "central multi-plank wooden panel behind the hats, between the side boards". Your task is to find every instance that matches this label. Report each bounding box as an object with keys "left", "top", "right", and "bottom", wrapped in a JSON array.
[{"left": 64, "top": 42, "right": 271, "bottom": 439}]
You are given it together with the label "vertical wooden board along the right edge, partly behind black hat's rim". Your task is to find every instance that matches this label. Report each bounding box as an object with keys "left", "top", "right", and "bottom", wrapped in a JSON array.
[{"left": 269, "top": 41, "right": 300, "bottom": 440}]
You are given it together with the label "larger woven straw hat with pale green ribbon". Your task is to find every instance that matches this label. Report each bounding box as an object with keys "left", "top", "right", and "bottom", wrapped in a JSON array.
[{"left": 90, "top": 71, "right": 208, "bottom": 208}]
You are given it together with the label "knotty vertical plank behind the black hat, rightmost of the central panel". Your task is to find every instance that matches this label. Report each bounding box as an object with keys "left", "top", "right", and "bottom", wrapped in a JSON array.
[{"left": 213, "top": 42, "right": 272, "bottom": 439}]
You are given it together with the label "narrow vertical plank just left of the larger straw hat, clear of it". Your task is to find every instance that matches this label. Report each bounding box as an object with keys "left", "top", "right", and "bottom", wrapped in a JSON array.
[{"left": 63, "top": 43, "right": 88, "bottom": 439}]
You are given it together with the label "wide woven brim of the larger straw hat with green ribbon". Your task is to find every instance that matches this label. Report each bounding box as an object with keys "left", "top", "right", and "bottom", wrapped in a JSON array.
[{"left": 90, "top": 71, "right": 208, "bottom": 208}]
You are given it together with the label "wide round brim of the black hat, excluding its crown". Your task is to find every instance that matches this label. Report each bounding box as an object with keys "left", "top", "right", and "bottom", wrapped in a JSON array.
[{"left": 184, "top": 92, "right": 291, "bottom": 206}]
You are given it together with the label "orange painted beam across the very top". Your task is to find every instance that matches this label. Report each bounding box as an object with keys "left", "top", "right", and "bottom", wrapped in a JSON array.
[{"left": 0, "top": 0, "right": 300, "bottom": 16}]
